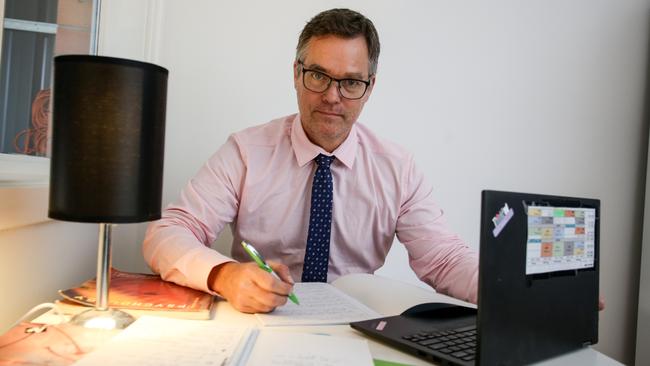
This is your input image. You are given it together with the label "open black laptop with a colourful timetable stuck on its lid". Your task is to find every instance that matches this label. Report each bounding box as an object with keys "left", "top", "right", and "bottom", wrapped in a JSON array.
[{"left": 350, "top": 190, "right": 600, "bottom": 366}]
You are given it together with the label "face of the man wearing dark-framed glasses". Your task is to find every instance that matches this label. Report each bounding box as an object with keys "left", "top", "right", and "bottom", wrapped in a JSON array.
[{"left": 293, "top": 36, "right": 374, "bottom": 152}]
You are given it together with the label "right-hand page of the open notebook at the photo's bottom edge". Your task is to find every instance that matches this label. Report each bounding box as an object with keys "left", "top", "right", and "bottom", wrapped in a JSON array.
[{"left": 246, "top": 329, "right": 373, "bottom": 366}]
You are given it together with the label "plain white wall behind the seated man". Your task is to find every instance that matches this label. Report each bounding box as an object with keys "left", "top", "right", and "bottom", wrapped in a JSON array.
[{"left": 144, "top": 0, "right": 650, "bottom": 363}]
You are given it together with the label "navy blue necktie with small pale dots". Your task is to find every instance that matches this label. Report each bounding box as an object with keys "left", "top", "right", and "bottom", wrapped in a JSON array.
[{"left": 302, "top": 154, "right": 334, "bottom": 282}]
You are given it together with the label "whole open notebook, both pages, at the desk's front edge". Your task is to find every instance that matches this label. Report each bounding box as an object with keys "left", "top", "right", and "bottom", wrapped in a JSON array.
[{"left": 75, "top": 316, "right": 373, "bottom": 366}]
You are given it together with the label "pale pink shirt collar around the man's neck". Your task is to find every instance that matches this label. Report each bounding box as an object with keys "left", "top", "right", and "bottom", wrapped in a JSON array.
[{"left": 291, "top": 114, "right": 359, "bottom": 168}]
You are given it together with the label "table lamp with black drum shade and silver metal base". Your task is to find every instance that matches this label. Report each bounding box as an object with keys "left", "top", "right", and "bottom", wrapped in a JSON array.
[{"left": 49, "top": 55, "right": 168, "bottom": 328}]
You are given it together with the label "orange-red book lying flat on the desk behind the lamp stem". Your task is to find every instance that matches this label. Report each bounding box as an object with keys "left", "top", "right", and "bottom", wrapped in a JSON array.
[{"left": 57, "top": 269, "right": 214, "bottom": 319}]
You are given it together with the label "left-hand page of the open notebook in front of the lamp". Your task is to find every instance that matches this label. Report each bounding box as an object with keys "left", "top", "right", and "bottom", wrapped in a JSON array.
[{"left": 75, "top": 316, "right": 248, "bottom": 366}]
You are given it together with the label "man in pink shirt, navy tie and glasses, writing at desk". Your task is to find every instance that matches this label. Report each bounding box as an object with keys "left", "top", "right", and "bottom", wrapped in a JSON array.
[{"left": 143, "top": 9, "right": 478, "bottom": 313}]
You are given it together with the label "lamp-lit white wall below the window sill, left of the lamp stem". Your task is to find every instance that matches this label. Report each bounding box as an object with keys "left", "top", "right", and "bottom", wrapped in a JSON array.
[{"left": 0, "top": 221, "right": 97, "bottom": 334}]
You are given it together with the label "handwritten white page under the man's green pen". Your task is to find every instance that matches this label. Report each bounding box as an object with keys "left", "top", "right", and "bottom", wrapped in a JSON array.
[{"left": 256, "top": 282, "right": 380, "bottom": 326}]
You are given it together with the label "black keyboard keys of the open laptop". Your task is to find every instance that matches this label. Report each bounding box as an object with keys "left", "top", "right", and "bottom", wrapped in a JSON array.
[{"left": 402, "top": 325, "right": 476, "bottom": 361}]
